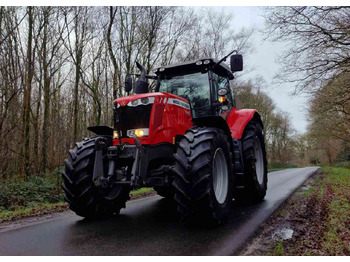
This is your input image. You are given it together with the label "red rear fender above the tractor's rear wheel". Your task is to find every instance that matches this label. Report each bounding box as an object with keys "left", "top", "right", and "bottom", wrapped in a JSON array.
[{"left": 227, "top": 108, "right": 264, "bottom": 139}]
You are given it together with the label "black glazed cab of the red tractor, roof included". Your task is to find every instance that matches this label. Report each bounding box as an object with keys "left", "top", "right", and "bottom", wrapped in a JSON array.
[{"left": 154, "top": 58, "right": 233, "bottom": 118}]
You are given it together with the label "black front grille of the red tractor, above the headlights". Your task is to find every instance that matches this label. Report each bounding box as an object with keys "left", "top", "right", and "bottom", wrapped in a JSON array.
[{"left": 114, "top": 104, "right": 152, "bottom": 138}]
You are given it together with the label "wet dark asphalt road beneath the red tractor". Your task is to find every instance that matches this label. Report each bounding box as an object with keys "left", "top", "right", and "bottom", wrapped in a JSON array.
[{"left": 0, "top": 167, "right": 318, "bottom": 255}]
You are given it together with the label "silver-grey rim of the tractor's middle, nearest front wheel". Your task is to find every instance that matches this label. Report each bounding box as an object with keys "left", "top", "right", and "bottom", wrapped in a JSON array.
[{"left": 213, "top": 148, "right": 228, "bottom": 204}]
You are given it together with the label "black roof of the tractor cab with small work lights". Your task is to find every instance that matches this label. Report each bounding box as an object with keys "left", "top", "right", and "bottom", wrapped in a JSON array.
[{"left": 153, "top": 58, "right": 233, "bottom": 79}]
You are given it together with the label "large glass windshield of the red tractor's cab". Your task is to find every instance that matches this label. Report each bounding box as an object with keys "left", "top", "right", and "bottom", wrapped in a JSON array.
[{"left": 159, "top": 72, "right": 211, "bottom": 117}]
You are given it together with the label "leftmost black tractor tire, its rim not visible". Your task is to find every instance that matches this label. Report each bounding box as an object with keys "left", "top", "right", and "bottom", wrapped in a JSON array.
[{"left": 62, "top": 137, "right": 130, "bottom": 218}]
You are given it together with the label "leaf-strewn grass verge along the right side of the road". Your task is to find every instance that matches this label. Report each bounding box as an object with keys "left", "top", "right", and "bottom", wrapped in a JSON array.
[{"left": 242, "top": 167, "right": 350, "bottom": 256}]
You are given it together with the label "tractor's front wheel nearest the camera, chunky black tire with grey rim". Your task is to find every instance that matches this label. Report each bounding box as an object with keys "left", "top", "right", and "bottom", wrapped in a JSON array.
[{"left": 173, "top": 126, "right": 233, "bottom": 224}]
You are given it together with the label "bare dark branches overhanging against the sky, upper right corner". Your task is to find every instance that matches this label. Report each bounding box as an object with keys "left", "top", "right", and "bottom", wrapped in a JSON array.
[{"left": 264, "top": 6, "right": 350, "bottom": 92}]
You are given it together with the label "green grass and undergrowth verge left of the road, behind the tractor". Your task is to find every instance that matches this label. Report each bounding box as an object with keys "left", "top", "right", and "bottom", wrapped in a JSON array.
[{"left": 0, "top": 168, "right": 155, "bottom": 223}]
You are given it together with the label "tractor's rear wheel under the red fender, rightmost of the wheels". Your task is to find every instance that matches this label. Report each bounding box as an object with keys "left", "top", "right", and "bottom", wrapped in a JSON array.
[{"left": 234, "top": 120, "right": 267, "bottom": 202}]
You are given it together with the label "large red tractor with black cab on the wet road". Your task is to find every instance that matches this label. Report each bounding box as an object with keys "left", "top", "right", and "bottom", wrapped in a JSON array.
[{"left": 62, "top": 52, "right": 267, "bottom": 223}]
